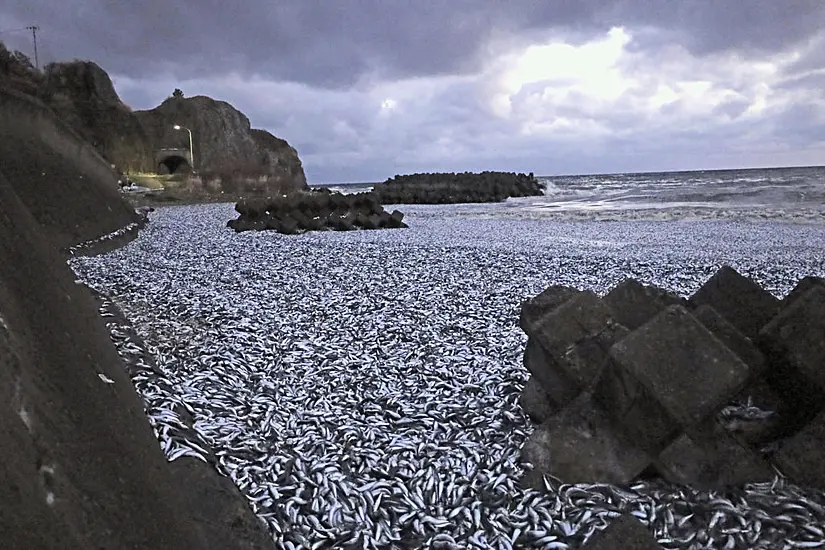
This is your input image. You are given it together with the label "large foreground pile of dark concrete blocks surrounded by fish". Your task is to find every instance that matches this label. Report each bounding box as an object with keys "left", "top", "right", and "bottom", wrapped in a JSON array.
[{"left": 520, "top": 266, "right": 825, "bottom": 547}]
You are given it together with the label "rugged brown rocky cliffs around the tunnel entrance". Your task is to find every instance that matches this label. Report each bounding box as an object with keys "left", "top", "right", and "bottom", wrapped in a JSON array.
[{"left": 0, "top": 44, "right": 306, "bottom": 194}]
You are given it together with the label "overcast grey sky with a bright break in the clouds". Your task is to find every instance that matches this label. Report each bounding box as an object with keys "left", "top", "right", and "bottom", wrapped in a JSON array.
[{"left": 0, "top": 0, "right": 825, "bottom": 183}]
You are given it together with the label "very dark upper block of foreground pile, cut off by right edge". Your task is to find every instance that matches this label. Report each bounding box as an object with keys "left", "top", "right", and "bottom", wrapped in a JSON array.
[{"left": 758, "top": 285, "right": 825, "bottom": 436}]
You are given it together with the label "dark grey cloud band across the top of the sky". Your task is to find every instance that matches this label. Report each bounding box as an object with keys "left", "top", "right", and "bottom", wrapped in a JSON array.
[{"left": 0, "top": 0, "right": 825, "bottom": 87}]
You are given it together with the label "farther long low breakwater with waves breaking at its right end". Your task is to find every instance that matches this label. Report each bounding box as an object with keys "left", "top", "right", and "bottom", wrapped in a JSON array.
[{"left": 373, "top": 172, "right": 544, "bottom": 204}]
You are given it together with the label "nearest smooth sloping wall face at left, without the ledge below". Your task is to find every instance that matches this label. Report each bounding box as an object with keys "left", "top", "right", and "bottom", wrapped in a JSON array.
[{"left": 0, "top": 176, "right": 206, "bottom": 548}]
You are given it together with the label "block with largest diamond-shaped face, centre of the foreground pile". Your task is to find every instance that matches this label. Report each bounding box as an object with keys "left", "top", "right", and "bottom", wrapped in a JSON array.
[{"left": 594, "top": 306, "right": 750, "bottom": 454}]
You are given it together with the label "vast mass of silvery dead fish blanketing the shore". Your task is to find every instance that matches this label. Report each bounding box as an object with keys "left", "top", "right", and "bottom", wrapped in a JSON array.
[{"left": 70, "top": 203, "right": 825, "bottom": 549}]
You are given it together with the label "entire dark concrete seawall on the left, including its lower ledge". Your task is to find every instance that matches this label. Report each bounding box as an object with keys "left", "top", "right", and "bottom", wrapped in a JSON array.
[{"left": 0, "top": 84, "right": 274, "bottom": 550}]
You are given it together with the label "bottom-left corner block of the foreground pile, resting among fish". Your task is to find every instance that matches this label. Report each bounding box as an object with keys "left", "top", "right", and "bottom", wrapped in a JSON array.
[{"left": 522, "top": 392, "right": 651, "bottom": 490}]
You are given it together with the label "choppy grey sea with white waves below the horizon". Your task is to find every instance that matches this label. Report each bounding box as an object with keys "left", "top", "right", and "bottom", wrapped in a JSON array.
[{"left": 316, "top": 166, "right": 825, "bottom": 223}]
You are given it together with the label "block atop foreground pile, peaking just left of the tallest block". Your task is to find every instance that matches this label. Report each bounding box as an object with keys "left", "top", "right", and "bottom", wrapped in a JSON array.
[{"left": 603, "top": 279, "right": 687, "bottom": 330}]
